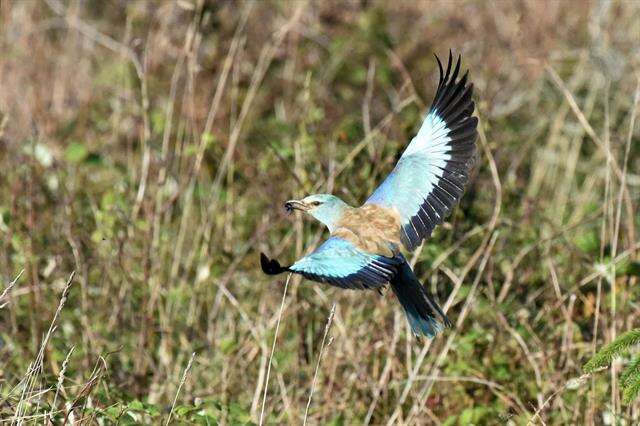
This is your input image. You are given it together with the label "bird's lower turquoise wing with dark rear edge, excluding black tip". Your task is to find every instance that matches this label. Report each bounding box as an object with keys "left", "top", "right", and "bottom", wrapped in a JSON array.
[{"left": 288, "top": 237, "right": 402, "bottom": 289}]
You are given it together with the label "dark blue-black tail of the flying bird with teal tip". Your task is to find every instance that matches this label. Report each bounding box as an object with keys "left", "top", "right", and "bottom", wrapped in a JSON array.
[{"left": 391, "top": 262, "right": 451, "bottom": 338}]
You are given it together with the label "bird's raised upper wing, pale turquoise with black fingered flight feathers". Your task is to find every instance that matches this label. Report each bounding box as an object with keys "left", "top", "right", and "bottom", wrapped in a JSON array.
[{"left": 366, "top": 52, "right": 478, "bottom": 250}]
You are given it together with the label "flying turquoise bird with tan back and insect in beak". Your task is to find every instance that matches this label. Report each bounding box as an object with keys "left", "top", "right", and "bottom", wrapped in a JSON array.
[{"left": 260, "top": 51, "right": 478, "bottom": 338}]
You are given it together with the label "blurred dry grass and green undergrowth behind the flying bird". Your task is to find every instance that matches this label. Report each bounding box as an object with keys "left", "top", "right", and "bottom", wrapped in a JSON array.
[{"left": 0, "top": 0, "right": 640, "bottom": 425}]
